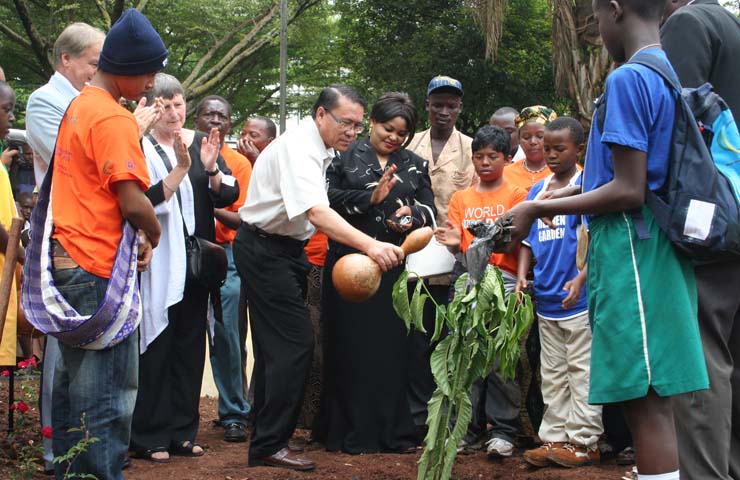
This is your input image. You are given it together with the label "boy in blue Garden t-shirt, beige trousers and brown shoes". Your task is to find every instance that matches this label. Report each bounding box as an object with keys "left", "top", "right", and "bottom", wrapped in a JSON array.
[{"left": 517, "top": 117, "right": 604, "bottom": 467}]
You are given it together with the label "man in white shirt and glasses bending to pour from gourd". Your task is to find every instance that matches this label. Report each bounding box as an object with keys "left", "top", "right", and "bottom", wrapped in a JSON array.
[{"left": 234, "top": 85, "right": 403, "bottom": 470}]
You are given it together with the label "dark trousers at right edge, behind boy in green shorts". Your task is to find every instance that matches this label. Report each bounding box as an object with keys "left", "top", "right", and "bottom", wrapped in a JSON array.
[{"left": 673, "top": 261, "right": 740, "bottom": 480}]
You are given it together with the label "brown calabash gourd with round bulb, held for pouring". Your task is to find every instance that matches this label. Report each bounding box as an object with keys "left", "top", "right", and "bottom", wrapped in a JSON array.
[{"left": 331, "top": 227, "right": 434, "bottom": 303}]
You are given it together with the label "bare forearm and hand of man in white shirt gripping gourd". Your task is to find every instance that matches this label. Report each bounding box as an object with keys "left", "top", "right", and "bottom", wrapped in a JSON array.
[{"left": 307, "top": 205, "right": 403, "bottom": 271}]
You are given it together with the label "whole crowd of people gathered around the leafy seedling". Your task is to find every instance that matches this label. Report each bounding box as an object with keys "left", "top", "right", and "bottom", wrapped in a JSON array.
[{"left": 0, "top": 0, "right": 740, "bottom": 480}]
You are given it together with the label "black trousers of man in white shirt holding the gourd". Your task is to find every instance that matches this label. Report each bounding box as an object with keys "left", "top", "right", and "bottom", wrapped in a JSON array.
[{"left": 234, "top": 224, "right": 314, "bottom": 462}]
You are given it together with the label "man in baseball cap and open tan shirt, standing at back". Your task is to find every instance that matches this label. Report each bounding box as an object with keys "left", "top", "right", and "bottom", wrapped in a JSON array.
[{"left": 407, "top": 75, "right": 475, "bottom": 434}]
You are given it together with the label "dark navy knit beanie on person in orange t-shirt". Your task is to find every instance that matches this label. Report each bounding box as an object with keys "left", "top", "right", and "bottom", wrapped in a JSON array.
[{"left": 98, "top": 8, "right": 167, "bottom": 75}]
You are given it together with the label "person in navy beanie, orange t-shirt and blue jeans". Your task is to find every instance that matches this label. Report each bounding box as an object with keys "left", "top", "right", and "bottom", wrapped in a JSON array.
[{"left": 42, "top": 9, "right": 167, "bottom": 480}]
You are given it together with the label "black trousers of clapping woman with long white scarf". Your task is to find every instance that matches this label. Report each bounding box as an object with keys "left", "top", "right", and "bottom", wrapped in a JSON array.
[{"left": 131, "top": 282, "right": 208, "bottom": 451}]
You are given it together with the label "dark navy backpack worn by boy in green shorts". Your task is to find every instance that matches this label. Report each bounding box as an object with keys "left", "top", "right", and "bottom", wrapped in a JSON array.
[{"left": 596, "top": 55, "right": 740, "bottom": 263}]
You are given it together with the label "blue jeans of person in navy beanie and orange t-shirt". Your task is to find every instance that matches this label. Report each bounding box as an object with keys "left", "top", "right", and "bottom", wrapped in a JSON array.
[{"left": 51, "top": 267, "right": 139, "bottom": 480}]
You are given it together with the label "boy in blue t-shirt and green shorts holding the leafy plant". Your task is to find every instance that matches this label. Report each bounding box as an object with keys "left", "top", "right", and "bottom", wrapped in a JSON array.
[{"left": 500, "top": 0, "right": 709, "bottom": 480}]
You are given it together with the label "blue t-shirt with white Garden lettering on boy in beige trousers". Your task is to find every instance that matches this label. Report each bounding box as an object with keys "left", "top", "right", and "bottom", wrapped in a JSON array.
[{"left": 522, "top": 172, "right": 588, "bottom": 320}]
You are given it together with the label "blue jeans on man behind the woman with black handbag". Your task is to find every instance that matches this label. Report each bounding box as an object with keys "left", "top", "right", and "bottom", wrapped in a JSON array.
[{"left": 210, "top": 245, "right": 250, "bottom": 426}]
